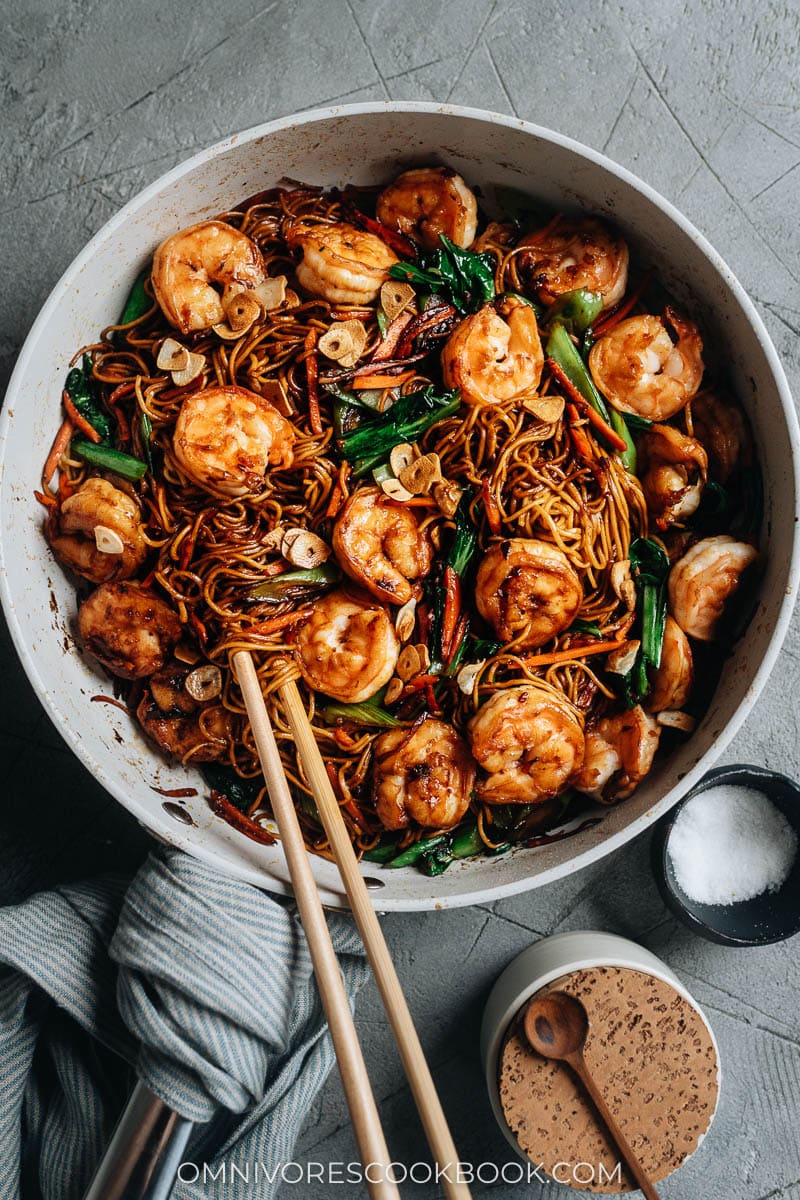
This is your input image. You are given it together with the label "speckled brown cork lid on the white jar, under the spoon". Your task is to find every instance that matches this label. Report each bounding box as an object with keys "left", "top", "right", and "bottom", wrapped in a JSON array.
[{"left": 498, "top": 967, "right": 720, "bottom": 1193}]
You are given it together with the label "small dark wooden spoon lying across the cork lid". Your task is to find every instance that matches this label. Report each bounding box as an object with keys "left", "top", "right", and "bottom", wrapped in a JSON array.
[{"left": 524, "top": 991, "right": 658, "bottom": 1200}]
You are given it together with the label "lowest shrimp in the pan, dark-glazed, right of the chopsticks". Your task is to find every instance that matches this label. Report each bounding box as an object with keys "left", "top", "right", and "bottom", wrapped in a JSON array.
[{"left": 373, "top": 716, "right": 475, "bottom": 829}]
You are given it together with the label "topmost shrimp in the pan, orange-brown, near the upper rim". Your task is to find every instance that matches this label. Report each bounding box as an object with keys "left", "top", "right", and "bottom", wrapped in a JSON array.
[{"left": 375, "top": 167, "right": 477, "bottom": 250}]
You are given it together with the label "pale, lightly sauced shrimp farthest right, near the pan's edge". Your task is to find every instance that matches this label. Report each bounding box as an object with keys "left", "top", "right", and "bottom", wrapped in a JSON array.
[{"left": 668, "top": 534, "right": 758, "bottom": 642}]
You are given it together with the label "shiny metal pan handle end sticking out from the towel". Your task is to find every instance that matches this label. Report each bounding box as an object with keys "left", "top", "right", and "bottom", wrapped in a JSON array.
[{"left": 85, "top": 1082, "right": 193, "bottom": 1200}]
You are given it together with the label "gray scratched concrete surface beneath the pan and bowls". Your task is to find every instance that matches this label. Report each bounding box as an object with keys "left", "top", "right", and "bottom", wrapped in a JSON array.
[{"left": 0, "top": 0, "right": 800, "bottom": 1200}]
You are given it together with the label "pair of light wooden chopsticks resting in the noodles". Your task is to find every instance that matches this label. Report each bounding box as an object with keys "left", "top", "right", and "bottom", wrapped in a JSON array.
[{"left": 233, "top": 650, "right": 470, "bottom": 1200}]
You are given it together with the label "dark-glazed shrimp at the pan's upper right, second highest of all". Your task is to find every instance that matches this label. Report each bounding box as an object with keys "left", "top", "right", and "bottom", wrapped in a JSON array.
[{"left": 517, "top": 217, "right": 628, "bottom": 308}]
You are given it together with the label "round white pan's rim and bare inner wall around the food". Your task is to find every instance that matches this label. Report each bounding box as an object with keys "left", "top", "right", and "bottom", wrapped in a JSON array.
[{"left": 0, "top": 103, "right": 799, "bottom": 911}]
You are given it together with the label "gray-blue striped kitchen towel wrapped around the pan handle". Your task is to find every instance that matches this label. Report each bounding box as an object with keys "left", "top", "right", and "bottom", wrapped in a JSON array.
[{"left": 0, "top": 848, "right": 367, "bottom": 1200}]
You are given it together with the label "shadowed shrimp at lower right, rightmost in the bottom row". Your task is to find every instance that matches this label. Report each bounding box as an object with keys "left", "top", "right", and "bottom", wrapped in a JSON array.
[{"left": 570, "top": 704, "right": 661, "bottom": 804}]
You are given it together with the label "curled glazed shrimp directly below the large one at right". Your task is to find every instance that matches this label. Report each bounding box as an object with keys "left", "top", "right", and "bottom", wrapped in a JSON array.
[{"left": 639, "top": 425, "right": 709, "bottom": 529}]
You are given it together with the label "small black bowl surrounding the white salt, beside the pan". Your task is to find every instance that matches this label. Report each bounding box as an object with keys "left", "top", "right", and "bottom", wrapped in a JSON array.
[{"left": 652, "top": 764, "right": 800, "bottom": 946}]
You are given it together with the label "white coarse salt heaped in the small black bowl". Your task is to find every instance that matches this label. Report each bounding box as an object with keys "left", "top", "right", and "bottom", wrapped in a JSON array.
[{"left": 668, "top": 785, "right": 798, "bottom": 905}]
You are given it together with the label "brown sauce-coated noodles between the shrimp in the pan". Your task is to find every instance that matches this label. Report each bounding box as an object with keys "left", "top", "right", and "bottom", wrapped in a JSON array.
[{"left": 38, "top": 177, "right": 762, "bottom": 854}]
